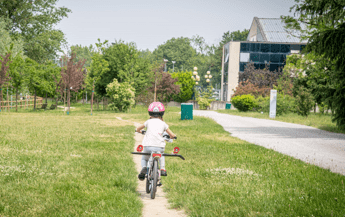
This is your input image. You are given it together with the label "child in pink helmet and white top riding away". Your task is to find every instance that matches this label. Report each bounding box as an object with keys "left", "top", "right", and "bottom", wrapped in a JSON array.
[{"left": 136, "top": 102, "right": 176, "bottom": 181}]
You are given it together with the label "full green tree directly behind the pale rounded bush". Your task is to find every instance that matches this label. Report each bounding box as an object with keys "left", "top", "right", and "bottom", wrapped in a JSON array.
[{"left": 96, "top": 41, "right": 152, "bottom": 96}]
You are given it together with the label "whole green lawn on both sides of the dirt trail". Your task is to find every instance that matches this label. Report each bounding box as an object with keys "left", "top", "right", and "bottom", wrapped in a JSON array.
[{"left": 0, "top": 105, "right": 345, "bottom": 216}]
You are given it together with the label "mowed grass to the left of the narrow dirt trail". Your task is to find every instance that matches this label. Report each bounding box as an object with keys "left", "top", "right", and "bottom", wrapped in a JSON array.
[{"left": 0, "top": 106, "right": 143, "bottom": 216}]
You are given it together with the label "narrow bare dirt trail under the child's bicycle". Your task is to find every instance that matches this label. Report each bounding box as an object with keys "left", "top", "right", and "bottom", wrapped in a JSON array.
[{"left": 118, "top": 117, "right": 186, "bottom": 217}]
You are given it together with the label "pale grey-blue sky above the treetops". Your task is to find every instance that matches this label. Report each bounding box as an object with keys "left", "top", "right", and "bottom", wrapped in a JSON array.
[{"left": 55, "top": 0, "right": 295, "bottom": 51}]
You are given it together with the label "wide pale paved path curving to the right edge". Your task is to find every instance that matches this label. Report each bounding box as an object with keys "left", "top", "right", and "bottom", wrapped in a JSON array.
[{"left": 193, "top": 110, "right": 345, "bottom": 175}]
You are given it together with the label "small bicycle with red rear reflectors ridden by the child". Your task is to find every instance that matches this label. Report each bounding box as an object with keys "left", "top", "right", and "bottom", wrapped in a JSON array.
[{"left": 132, "top": 130, "right": 185, "bottom": 199}]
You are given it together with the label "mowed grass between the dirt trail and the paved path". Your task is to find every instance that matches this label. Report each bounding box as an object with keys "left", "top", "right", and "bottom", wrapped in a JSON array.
[{"left": 123, "top": 107, "right": 345, "bottom": 217}]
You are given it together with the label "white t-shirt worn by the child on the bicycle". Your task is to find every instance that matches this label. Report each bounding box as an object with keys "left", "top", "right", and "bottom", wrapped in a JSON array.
[{"left": 142, "top": 118, "right": 169, "bottom": 148}]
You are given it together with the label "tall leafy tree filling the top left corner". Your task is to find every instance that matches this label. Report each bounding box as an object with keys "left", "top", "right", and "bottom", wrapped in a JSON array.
[{"left": 0, "top": 0, "right": 71, "bottom": 63}]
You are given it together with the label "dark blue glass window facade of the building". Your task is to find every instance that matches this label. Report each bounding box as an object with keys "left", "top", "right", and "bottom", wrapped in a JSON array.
[{"left": 236, "top": 43, "right": 305, "bottom": 72}]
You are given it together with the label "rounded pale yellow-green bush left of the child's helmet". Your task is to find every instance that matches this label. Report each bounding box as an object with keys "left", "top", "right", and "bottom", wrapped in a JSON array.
[{"left": 107, "top": 79, "right": 135, "bottom": 112}]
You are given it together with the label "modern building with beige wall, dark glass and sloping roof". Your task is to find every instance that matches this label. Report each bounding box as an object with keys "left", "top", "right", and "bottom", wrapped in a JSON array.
[{"left": 221, "top": 17, "right": 307, "bottom": 101}]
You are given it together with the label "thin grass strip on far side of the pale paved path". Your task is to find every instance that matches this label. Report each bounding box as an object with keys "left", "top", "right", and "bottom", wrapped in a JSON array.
[{"left": 217, "top": 109, "right": 345, "bottom": 133}]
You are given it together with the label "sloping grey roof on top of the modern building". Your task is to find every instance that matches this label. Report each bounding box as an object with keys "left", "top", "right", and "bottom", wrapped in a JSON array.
[{"left": 247, "top": 17, "right": 307, "bottom": 43}]
